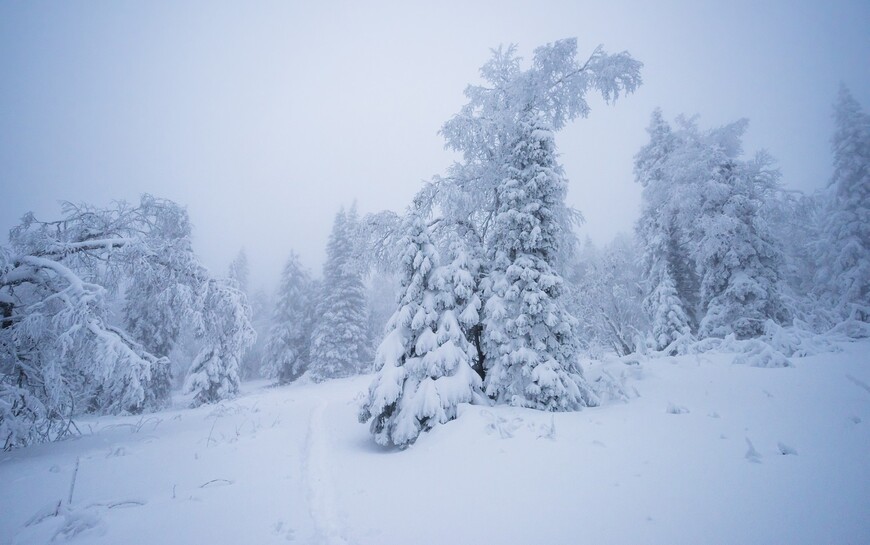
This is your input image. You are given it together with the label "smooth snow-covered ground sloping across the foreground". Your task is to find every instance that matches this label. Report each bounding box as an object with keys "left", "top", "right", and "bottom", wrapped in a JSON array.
[{"left": 0, "top": 341, "right": 870, "bottom": 545}]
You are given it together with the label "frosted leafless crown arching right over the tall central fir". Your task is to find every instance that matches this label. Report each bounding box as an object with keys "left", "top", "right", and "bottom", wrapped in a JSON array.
[{"left": 442, "top": 38, "right": 642, "bottom": 251}]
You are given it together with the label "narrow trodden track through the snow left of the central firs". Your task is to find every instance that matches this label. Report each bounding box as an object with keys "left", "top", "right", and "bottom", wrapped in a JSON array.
[{"left": 302, "top": 401, "right": 350, "bottom": 545}]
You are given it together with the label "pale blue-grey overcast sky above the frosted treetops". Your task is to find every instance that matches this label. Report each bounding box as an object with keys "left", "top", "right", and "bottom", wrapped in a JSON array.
[{"left": 0, "top": 0, "right": 870, "bottom": 288}]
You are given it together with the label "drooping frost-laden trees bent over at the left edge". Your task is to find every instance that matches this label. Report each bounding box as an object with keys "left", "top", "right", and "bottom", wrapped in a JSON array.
[{"left": 0, "top": 195, "right": 255, "bottom": 448}]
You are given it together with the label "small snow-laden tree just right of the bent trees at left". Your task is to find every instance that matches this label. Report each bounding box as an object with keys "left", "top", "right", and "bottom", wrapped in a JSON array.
[{"left": 184, "top": 279, "right": 256, "bottom": 406}]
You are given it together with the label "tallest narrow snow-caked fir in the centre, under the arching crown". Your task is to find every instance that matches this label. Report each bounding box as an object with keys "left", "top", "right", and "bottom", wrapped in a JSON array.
[{"left": 483, "top": 114, "right": 596, "bottom": 411}]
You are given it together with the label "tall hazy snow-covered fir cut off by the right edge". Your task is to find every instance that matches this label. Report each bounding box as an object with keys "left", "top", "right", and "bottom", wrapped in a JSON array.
[{"left": 816, "top": 86, "right": 870, "bottom": 321}]
